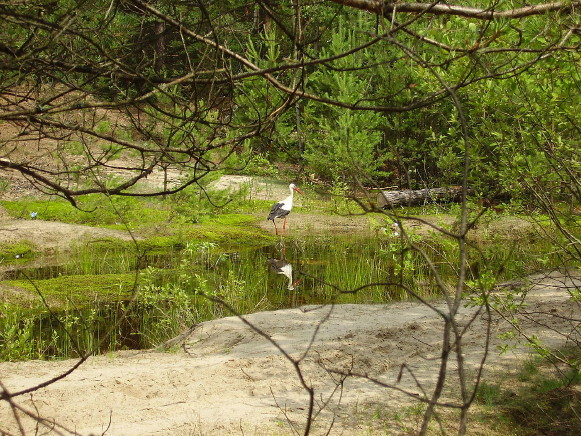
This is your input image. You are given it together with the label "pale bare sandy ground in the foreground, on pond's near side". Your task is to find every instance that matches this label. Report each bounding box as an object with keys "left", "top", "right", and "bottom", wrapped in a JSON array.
[{"left": 0, "top": 275, "right": 581, "bottom": 435}]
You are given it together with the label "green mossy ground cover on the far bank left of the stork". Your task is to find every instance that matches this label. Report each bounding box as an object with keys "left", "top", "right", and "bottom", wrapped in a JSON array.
[{"left": 1, "top": 180, "right": 270, "bottom": 245}]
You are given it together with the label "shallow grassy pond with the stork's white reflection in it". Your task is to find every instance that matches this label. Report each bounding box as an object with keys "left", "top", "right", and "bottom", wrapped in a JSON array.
[{"left": 0, "top": 234, "right": 548, "bottom": 360}]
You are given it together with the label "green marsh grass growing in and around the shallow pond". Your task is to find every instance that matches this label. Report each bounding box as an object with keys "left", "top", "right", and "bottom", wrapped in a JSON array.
[{"left": 0, "top": 203, "right": 572, "bottom": 360}]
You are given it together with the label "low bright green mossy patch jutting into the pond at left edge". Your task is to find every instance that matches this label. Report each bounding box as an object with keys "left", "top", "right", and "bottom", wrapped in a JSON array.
[{"left": 3, "top": 273, "right": 135, "bottom": 306}]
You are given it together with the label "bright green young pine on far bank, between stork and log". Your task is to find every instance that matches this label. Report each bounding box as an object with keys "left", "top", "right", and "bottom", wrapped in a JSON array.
[{"left": 303, "top": 14, "right": 384, "bottom": 183}]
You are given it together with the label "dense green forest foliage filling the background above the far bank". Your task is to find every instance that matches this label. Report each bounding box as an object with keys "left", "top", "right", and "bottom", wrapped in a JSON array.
[{"left": 1, "top": 1, "right": 580, "bottom": 204}]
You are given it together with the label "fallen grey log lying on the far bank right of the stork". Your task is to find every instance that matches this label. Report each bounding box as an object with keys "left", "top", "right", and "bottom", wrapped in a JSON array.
[{"left": 377, "top": 186, "right": 462, "bottom": 208}]
